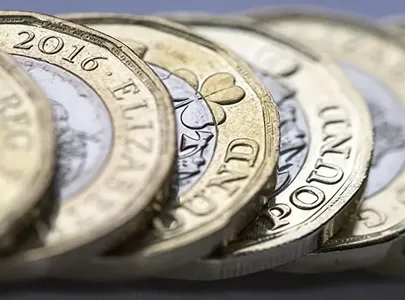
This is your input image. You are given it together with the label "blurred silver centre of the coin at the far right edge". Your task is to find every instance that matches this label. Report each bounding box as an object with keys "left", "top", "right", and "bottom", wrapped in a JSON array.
[{"left": 340, "top": 62, "right": 405, "bottom": 199}]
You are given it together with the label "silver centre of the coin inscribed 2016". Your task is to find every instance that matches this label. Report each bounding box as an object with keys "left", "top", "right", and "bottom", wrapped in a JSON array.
[{"left": 14, "top": 55, "right": 113, "bottom": 201}]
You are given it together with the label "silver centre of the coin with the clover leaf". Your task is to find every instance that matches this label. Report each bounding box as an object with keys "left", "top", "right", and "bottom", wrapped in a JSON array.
[{"left": 149, "top": 64, "right": 218, "bottom": 195}]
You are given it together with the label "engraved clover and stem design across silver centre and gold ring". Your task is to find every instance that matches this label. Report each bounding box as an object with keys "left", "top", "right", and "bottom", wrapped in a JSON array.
[{"left": 166, "top": 69, "right": 245, "bottom": 189}]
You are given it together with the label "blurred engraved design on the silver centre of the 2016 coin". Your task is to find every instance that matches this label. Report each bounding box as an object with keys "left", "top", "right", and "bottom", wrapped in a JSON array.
[{"left": 49, "top": 99, "right": 100, "bottom": 197}]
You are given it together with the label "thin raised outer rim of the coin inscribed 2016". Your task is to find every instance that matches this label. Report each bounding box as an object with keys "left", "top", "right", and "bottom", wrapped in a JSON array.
[{"left": 0, "top": 11, "right": 177, "bottom": 263}]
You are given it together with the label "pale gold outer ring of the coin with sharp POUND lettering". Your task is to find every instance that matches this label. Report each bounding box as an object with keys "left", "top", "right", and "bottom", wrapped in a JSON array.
[{"left": 153, "top": 13, "right": 372, "bottom": 280}]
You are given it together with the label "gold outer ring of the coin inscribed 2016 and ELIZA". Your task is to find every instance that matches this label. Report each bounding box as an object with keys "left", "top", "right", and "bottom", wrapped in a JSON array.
[{"left": 0, "top": 11, "right": 176, "bottom": 280}]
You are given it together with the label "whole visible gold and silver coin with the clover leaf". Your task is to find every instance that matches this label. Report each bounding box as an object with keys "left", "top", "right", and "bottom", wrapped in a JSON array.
[{"left": 60, "top": 14, "right": 279, "bottom": 280}]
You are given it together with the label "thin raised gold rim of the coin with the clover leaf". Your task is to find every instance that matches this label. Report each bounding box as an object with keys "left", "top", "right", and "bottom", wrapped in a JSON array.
[{"left": 56, "top": 13, "right": 279, "bottom": 279}]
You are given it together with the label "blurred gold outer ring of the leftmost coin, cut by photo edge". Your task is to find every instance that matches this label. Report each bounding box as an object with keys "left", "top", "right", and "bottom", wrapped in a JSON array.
[{"left": 0, "top": 53, "right": 56, "bottom": 252}]
